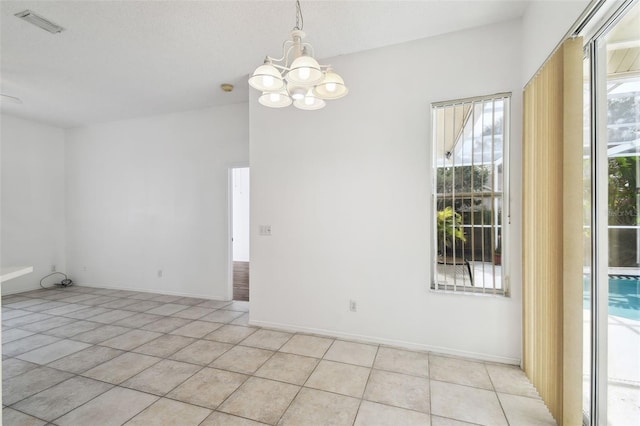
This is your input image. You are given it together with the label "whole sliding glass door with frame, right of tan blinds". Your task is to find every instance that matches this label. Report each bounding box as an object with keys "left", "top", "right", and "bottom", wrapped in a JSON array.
[{"left": 583, "top": 1, "right": 640, "bottom": 426}]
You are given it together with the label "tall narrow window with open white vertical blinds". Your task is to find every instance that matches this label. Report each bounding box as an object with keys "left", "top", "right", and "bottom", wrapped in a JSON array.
[{"left": 431, "top": 94, "right": 511, "bottom": 296}]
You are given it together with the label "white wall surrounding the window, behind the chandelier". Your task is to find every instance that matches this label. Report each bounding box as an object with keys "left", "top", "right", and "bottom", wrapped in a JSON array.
[{"left": 249, "top": 21, "right": 522, "bottom": 363}]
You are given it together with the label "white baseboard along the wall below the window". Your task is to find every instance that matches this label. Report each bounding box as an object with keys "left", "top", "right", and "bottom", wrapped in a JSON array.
[{"left": 249, "top": 319, "right": 520, "bottom": 366}]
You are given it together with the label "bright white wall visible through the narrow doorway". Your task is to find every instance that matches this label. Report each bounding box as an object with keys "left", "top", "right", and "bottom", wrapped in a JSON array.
[{"left": 232, "top": 167, "right": 251, "bottom": 262}]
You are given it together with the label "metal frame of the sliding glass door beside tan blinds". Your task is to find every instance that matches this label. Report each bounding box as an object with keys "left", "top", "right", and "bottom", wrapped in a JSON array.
[{"left": 576, "top": 0, "right": 638, "bottom": 426}]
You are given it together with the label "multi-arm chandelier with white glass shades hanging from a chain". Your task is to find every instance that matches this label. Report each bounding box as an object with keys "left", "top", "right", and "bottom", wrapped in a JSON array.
[{"left": 249, "top": 0, "right": 348, "bottom": 110}]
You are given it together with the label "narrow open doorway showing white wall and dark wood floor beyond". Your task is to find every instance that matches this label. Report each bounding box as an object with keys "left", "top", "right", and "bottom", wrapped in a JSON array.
[{"left": 231, "top": 167, "right": 250, "bottom": 301}]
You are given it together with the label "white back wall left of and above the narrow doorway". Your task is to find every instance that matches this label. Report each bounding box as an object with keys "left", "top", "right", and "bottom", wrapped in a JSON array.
[{"left": 66, "top": 103, "right": 249, "bottom": 299}]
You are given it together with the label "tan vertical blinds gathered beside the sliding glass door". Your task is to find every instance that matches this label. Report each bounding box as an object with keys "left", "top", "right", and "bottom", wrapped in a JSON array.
[{"left": 522, "top": 39, "right": 583, "bottom": 425}]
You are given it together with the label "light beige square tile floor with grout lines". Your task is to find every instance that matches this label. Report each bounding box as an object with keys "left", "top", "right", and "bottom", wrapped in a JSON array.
[{"left": 2, "top": 287, "right": 555, "bottom": 426}]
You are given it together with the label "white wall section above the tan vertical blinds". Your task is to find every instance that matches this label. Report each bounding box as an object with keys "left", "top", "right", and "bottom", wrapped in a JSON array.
[{"left": 522, "top": 0, "right": 591, "bottom": 85}]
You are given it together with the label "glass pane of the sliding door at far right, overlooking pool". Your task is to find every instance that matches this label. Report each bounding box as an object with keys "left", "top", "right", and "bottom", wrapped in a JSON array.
[{"left": 600, "top": 3, "right": 640, "bottom": 425}]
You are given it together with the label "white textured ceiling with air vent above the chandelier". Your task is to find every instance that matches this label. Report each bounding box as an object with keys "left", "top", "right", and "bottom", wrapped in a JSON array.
[{"left": 0, "top": 0, "right": 529, "bottom": 128}]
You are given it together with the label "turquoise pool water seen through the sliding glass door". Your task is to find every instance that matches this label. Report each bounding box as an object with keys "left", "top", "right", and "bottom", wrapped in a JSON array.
[{"left": 584, "top": 275, "right": 640, "bottom": 321}]
